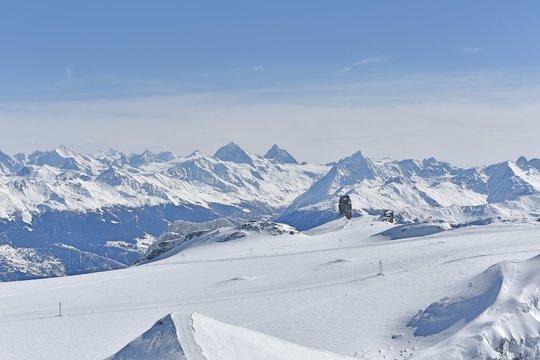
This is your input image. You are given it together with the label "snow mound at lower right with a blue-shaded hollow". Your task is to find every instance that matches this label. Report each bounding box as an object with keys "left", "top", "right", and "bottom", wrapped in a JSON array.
[{"left": 408, "top": 256, "right": 540, "bottom": 360}]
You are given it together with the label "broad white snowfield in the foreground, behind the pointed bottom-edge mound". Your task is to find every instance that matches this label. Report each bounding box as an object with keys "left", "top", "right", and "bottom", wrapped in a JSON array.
[{"left": 0, "top": 217, "right": 540, "bottom": 360}]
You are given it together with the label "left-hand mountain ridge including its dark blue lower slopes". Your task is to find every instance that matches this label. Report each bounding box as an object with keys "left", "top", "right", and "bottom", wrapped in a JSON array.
[{"left": 0, "top": 143, "right": 326, "bottom": 280}]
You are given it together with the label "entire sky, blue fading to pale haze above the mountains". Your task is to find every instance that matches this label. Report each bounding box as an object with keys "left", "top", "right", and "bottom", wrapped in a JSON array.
[{"left": 0, "top": 0, "right": 540, "bottom": 167}]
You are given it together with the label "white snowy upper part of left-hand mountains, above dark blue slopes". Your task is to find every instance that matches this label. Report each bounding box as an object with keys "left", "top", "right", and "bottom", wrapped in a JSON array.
[{"left": 0, "top": 144, "right": 328, "bottom": 223}]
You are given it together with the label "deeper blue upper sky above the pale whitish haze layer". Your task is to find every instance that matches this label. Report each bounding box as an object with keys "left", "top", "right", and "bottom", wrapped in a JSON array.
[{"left": 0, "top": 0, "right": 540, "bottom": 99}]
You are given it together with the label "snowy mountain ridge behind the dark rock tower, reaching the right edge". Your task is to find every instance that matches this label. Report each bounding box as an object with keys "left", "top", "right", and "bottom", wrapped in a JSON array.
[{"left": 278, "top": 152, "right": 540, "bottom": 230}]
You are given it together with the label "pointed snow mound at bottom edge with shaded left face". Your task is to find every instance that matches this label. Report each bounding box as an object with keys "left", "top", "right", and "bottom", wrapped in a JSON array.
[{"left": 107, "top": 313, "right": 350, "bottom": 360}]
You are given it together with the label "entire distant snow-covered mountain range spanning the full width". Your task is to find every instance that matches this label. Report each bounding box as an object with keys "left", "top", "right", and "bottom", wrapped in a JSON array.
[{"left": 0, "top": 143, "right": 540, "bottom": 280}]
